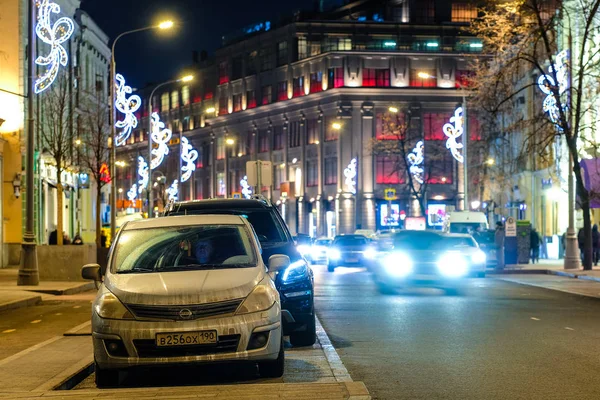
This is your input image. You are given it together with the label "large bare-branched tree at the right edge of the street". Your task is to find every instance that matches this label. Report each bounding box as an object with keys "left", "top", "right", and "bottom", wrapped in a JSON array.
[{"left": 470, "top": 0, "right": 600, "bottom": 269}]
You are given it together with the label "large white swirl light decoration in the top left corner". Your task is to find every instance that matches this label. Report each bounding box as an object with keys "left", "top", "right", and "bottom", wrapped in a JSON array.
[{"left": 33, "top": 0, "right": 75, "bottom": 93}]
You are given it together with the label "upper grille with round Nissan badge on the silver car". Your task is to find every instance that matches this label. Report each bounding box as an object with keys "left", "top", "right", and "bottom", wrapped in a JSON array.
[{"left": 127, "top": 299, "right": 242, "bottom": 321}]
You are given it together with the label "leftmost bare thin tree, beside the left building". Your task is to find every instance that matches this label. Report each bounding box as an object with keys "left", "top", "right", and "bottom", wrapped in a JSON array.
[{"left": 39, "top": 73, "right": 74, "bottom": 246}]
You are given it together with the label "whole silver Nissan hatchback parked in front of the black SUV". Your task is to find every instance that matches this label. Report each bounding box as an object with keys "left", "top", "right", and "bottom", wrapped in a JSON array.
[{"left": 82, "top": 215, "right": 290, "bottom": 387}]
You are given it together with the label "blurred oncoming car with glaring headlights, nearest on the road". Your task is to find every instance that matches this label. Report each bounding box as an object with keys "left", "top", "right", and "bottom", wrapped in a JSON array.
[{"left": 373, "top": 231, "right": 486, "bottom": 292}]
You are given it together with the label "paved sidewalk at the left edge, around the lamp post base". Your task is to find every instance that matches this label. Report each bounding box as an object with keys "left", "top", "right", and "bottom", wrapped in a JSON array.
[{"left": 0, "top": 265, "right": 95, "bottom": 312}]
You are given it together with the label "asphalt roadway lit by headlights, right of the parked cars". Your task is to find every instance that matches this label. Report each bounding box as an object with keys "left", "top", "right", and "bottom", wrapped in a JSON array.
[{"left": 314, "top": 266, "right": 600, "bottom": 399}]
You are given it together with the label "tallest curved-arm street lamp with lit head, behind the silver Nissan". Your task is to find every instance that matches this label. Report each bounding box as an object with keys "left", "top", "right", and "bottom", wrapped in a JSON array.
[{"left": 109, "top": 21, "right": 173, "bottom": 233}]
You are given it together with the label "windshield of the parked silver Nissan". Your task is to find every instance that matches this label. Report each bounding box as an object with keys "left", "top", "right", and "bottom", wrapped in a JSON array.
[{"left": 113, "top": 225, "right": 257, "bottom": 273}]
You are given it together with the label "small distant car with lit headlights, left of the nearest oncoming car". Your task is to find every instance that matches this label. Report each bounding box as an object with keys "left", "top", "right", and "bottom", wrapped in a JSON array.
[{"left": 327, "top": 235, "right": 377, "bottom": 272}]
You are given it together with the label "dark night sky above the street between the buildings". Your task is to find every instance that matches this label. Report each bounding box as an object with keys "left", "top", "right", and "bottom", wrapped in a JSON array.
[{"left": 81, "top": 0, "right": 314, "bottom": 87}]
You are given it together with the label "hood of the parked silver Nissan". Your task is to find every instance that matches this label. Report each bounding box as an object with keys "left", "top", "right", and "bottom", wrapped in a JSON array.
[{"left": 104, "top": 266, "right": 265, "bottom": 305}]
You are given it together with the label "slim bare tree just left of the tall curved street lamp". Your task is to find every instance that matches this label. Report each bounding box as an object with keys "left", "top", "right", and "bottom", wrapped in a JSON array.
[{"left": 78, "top": 89, "right": 110, "bottom": 247}]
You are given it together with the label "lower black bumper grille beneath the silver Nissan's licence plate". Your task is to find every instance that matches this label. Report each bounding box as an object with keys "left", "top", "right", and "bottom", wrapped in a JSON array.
[{"left": 133, "top": 335, "right": 240, "bottom": 358}]
